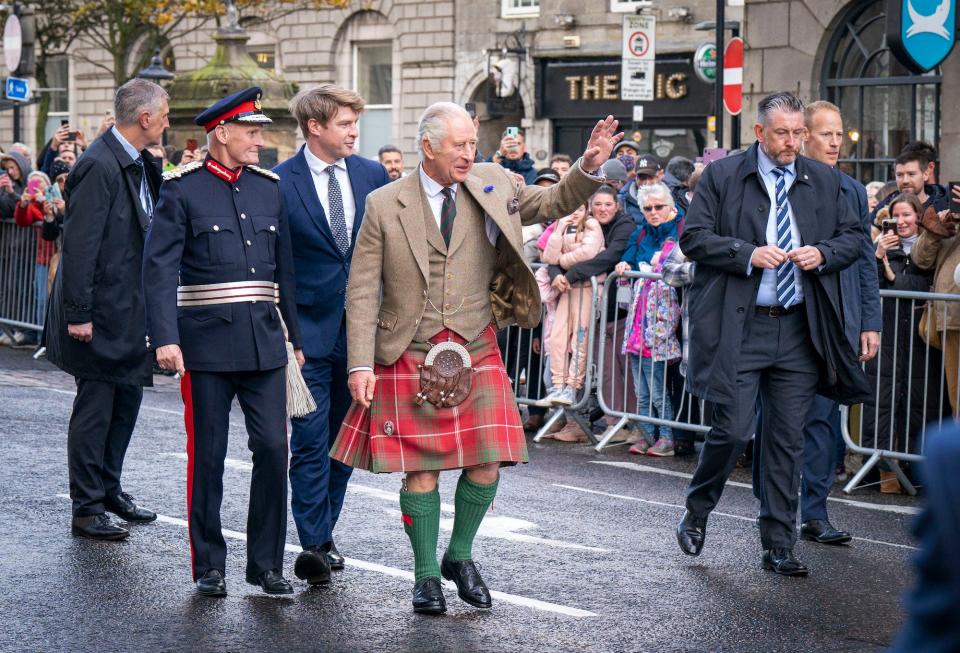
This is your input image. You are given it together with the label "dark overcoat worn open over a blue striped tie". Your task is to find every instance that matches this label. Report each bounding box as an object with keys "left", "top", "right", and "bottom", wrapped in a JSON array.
[{"left": 680, "top": 144, "right": 866, "bottom": 402}]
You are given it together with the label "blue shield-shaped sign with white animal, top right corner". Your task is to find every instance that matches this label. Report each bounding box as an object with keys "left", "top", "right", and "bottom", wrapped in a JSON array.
[{"left": 887, "top": 0, "right": 957, "bottom": 73}]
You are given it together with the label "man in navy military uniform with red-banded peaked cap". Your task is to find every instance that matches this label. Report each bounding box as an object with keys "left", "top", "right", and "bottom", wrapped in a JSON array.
[{"left": 143, "top": 87, "right": 302, "bottom": 596}]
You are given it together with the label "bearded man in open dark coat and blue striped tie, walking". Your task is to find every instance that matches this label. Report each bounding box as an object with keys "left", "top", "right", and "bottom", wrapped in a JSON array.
[{"left": 677, "top": 93, "right": 865, "bottom": 575}]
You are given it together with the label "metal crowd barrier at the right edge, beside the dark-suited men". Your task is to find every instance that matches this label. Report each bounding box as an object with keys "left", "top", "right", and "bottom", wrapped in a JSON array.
[{"left": 841, "top": 290, "right": 960, "bottom": 494}]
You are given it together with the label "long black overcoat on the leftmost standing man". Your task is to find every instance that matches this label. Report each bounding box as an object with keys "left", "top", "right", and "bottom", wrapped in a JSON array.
[{"left": 45, "top": 131, "right": 161, "bottom": 386}]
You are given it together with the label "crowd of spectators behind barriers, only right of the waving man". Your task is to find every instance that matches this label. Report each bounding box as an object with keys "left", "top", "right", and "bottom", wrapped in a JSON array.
[{"left": 489, "top": 121, "right": 960, "bottom": 491}]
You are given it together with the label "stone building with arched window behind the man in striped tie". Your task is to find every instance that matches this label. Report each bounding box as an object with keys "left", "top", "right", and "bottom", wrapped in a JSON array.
[{"left": 743, "top": 0, "right": 960, "bottom": 183}]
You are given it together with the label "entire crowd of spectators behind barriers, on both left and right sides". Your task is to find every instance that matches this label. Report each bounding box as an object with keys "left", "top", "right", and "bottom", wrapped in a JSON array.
[{"left": 0, "top": 111, "right": 960, "bottom": 486}]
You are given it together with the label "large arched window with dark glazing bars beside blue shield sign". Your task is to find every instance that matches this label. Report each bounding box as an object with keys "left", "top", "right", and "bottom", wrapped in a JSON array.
[{"left": 821, "top": 0, "right": 941, "bottom": 183}]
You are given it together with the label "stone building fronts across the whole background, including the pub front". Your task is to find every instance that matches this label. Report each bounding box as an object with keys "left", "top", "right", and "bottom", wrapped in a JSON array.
[{"left": 0, "top": 0, "right": 960, "bottom": 180}]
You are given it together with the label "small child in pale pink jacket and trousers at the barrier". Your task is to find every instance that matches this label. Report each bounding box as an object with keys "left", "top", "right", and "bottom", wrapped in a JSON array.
[{"left": 536, "top": 207, "right": 604, "bottom": 406}]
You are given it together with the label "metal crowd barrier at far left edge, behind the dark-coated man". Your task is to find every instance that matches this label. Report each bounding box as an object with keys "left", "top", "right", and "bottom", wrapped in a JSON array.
[{"left": 0, "top": 220, "right": 46, "bottom": 331}]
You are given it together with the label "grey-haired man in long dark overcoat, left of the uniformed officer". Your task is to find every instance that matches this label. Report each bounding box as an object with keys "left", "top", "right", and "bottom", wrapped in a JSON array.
[{"left": 45, "top": 79, "right": 168, "bottom": 539}]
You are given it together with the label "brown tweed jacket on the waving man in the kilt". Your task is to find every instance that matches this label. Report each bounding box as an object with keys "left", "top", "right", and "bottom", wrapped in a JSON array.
[{"left": 347, "top": 163, "right": 601, "bottom": 369}]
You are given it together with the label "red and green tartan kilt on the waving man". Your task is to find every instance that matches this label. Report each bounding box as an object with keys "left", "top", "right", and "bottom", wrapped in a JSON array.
[{"left": 330, "top": 325, "right": 529, "bottom": 473}]
